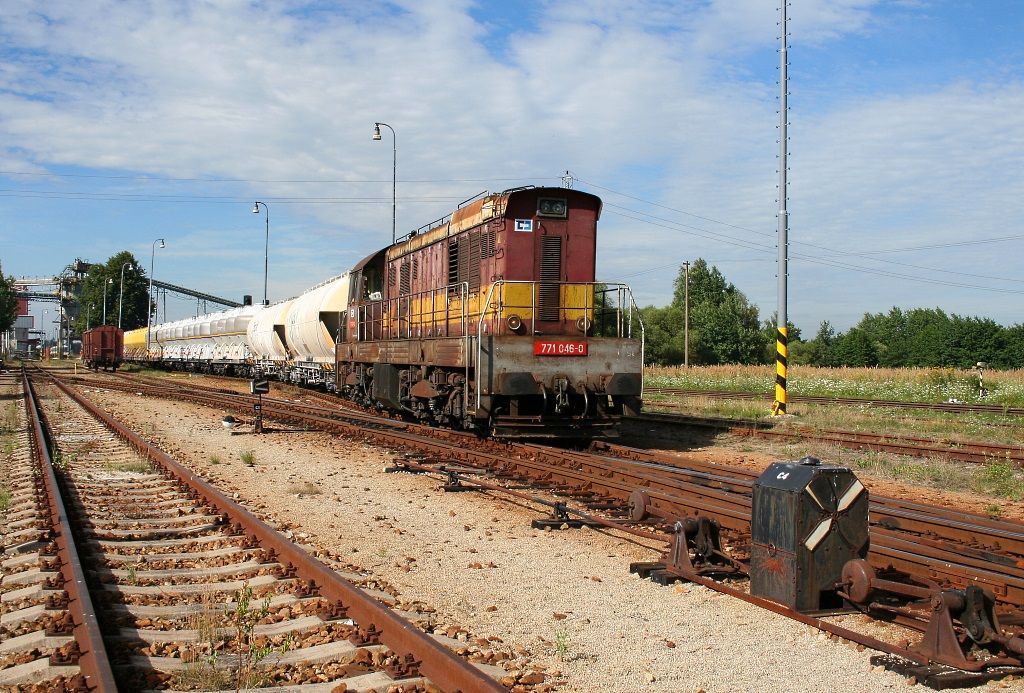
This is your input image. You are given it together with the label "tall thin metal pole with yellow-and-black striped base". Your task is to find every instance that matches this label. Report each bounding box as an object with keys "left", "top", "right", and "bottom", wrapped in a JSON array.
[{"left": 772, "top": 0, "right": 790, "bottom": 416}]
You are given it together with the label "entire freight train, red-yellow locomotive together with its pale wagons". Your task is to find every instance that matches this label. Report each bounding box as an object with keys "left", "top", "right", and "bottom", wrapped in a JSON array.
[{"left": 124, "top": 186, "right": 644, "bottom": 438}]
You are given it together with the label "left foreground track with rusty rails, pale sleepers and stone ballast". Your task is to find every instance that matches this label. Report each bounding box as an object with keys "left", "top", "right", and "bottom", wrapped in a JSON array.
[{"left": 0, "top": 377, "right": 506, "bottom": 691}]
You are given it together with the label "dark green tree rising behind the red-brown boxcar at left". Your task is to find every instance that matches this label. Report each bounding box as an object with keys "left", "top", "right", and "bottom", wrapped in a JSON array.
[{"left": 75, "top": 251, "right": 148, "bottom": 335}]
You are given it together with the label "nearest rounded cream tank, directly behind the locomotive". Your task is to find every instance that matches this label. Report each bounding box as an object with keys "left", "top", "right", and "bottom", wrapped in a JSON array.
[{"left": 285, "top": 272, "right": 350, "bottom": 386}]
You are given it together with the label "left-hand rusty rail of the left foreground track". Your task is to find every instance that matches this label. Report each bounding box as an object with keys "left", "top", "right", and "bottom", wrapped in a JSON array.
[{"left": 22, "top": 369, "right": 118, "bottom": 693}]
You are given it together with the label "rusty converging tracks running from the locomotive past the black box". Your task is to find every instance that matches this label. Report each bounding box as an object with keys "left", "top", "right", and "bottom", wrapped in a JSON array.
[{"left": 56, "top": 368, "right": 1024, "bottom": 608}]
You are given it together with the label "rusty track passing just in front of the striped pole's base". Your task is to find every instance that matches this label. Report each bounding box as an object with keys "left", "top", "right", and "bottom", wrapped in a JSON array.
[{"left": 628, "top": 413, "right": 1024, "bottom": 467}]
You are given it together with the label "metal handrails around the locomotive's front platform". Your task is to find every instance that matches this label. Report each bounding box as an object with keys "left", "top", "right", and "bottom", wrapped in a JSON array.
[{"left": 465, "top": 279, "right": 647, "bottom": 409}]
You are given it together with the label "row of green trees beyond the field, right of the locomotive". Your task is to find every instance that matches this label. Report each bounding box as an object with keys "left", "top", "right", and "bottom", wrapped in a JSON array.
[{"left": 641, "top": 259, "right": 1024, "bottom": 369}]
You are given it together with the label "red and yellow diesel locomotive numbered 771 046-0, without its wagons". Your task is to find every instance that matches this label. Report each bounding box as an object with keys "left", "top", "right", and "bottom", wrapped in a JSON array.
[{"left": 335, "top": 187, "right": 643, "bottom": 437}]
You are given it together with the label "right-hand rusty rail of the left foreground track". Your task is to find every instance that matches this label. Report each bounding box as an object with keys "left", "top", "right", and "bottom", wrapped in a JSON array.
[{"left": 36, "top": 370, "right": 507, "bottom": 693}]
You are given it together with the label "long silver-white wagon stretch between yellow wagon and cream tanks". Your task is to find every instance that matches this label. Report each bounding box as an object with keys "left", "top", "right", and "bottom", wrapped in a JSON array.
[{"left": 151, "top": 306, "right": 263, "bottom": 374}]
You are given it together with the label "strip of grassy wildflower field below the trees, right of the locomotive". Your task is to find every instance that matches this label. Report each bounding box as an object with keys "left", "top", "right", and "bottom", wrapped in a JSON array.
[{"left": 644, "top": 365, "right": 1024, "bottom": 406}]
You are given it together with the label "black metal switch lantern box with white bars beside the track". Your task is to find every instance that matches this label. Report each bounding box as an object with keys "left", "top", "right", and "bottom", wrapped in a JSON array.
[{"left": 751, "top": 457, "right": 868, "bottom": 612}]
